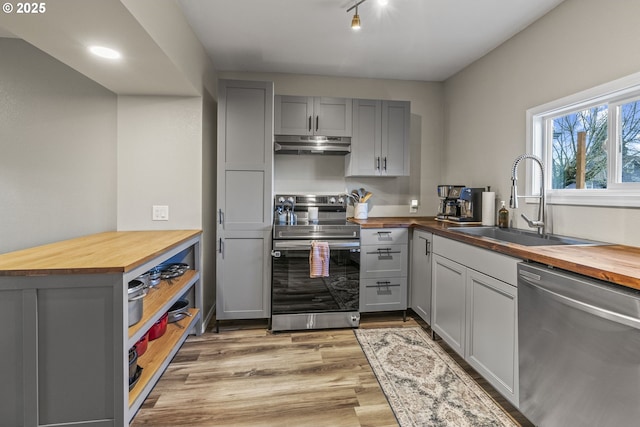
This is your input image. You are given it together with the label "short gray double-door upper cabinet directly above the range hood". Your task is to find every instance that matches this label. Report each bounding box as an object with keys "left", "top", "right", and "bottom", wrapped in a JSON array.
[{"left": 274, "top": 95, "right": 352, "bottom": 136}]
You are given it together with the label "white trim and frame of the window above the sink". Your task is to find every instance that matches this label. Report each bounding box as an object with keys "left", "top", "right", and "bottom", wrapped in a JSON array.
[{"left": 525, "top": 73, "right": 640, "bottom": 207}]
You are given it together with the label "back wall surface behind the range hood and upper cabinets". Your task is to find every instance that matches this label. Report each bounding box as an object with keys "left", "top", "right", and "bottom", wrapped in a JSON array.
[{"left": 220, "top": 72, "right": 443, "bottom": 216}]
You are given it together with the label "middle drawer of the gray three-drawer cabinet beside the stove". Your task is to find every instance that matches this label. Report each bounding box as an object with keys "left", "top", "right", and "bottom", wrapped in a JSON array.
[{"left": 360, "top": 245, "right": 407, "bottom": 279}]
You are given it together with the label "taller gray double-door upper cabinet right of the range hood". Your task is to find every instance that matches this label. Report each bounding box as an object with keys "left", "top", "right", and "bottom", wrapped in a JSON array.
[{"left": 345, "top": 99, "right": 411, "bottom": 176}]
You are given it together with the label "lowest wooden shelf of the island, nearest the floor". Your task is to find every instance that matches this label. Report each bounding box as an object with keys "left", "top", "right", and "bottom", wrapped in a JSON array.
[{"left": 129, "top": 308, "right": 200, "bottom": 415}]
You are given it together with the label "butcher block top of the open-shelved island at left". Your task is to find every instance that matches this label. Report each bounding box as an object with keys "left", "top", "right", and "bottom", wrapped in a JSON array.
[{"left": 0, "top": 230, "right": 201, "bottom": 276}]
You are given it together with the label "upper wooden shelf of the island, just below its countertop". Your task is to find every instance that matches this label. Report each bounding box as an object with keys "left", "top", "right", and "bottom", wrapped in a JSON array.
[{"left": 129, "top": 270, "right": 200, "bottom": 347}]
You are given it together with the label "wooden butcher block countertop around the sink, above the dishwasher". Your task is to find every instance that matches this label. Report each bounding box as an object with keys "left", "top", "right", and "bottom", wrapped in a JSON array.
[{"left": 350, "top": 217, "right": 640, "bottom": 289}]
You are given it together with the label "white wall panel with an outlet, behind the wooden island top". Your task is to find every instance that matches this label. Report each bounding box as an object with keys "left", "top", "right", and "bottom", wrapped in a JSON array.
[{"left": 117, "top": 96, "right": 203, "bottom": 230}]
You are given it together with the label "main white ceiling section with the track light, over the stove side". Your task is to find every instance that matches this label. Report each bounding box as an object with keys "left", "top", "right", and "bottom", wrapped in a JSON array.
[{"left": 180, "top": 0, "right": 562, "bottom": 81}]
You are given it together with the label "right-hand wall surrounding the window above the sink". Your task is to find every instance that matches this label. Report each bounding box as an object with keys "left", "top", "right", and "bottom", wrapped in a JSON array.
[{"left": 442, "top": 0, "right": 640, "bottom": 246}]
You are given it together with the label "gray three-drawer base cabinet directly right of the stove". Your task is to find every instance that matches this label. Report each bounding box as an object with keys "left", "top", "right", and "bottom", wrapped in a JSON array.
[{"left": 360, "top": 228, "right": 408, "bottom": 313}]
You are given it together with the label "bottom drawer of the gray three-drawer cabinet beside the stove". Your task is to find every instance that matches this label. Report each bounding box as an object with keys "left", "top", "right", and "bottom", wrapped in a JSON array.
[{"left": 360, "top": 277, "right": 407, "bottom": 312}]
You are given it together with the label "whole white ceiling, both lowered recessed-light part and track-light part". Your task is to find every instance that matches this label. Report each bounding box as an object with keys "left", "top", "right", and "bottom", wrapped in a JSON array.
[{"left": 0, "top": 0, "right": 562, "bottom": 95}]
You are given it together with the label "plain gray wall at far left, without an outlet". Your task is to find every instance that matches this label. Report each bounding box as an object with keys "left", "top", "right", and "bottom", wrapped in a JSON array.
[{"left": 0, "top": 38, "right": 116, "bottom": 253}]
